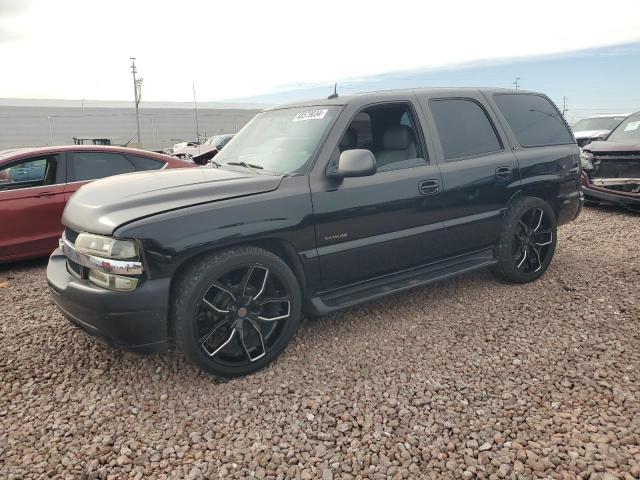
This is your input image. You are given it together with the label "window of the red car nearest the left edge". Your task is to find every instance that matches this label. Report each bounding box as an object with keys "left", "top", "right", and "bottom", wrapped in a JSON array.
[{"left": 0, "top": 155, "right": 58, "bottom": 190}]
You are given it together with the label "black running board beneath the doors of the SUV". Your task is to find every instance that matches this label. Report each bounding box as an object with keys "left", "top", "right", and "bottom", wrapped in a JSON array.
[{"left": 311, "top": 248, "right": 497, "bottom": 315}]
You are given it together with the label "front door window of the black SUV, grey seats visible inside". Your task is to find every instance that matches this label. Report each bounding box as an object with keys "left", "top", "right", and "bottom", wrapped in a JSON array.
[{"left": 338, "top": 103, "right": 429, "bottom": 172}]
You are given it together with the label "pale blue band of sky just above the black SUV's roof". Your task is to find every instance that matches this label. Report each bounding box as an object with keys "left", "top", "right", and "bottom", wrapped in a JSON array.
[{"left": 236, "top": 42, "right": 640, "bottom": 123}]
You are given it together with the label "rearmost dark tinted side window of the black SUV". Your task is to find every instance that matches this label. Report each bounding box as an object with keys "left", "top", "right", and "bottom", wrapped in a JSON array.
[{"left": 495, "top": 94, "right": 573, "bottom": 147}]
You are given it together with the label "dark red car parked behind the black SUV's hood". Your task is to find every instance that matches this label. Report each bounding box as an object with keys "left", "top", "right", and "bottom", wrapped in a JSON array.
[{"left": 0, "top": 145, "right": 195, "bottom": 263}]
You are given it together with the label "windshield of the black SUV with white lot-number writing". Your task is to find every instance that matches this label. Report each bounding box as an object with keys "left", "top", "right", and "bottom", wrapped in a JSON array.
[{"left": 215, "top": 106, "right": 340, "bottom": 173}]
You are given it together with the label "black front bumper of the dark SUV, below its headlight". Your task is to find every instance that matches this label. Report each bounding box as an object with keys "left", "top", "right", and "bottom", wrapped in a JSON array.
[{"left": 47, "top": 248, "right": 170, "bottom": 354}]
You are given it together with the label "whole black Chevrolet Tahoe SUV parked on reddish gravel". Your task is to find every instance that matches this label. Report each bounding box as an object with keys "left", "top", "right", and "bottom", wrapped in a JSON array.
[{"left": 47, "top": 89, "right": 582, "bottom": 377}]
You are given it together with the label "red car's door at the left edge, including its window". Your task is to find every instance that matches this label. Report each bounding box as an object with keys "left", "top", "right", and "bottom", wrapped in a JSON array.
[{"left": 0, "top": 154, "right": 65, "bottom": 261}]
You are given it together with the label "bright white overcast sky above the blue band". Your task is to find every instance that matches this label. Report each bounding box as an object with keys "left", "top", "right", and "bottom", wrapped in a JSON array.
[{"left": 0, "top": 0, "right": 640, "bottom": 118}]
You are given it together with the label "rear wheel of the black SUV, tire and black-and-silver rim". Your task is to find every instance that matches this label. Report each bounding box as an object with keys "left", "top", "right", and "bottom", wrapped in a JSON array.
[{"left": 491, "top": 197, "right": 557, "bottom": 283}]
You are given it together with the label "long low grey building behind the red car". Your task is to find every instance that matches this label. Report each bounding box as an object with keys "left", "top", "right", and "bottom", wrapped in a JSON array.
[{"left": 0, "top": 99, "right": 261, "bottom": 150}]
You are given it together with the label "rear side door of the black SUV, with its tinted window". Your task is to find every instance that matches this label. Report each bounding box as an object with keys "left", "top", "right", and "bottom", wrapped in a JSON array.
[{"left": 421, "top": 90, "right": 520, "bottom": 255}]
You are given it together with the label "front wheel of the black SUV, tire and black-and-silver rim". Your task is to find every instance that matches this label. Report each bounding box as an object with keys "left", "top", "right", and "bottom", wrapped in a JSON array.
[{"left": 171, "top": 246, "right": 302, "bottom": 378}]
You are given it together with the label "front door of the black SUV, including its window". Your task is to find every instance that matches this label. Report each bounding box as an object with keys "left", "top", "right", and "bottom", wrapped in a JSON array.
[{"left": 310, "top": 96, "right": 443, "bottom": 291}]
